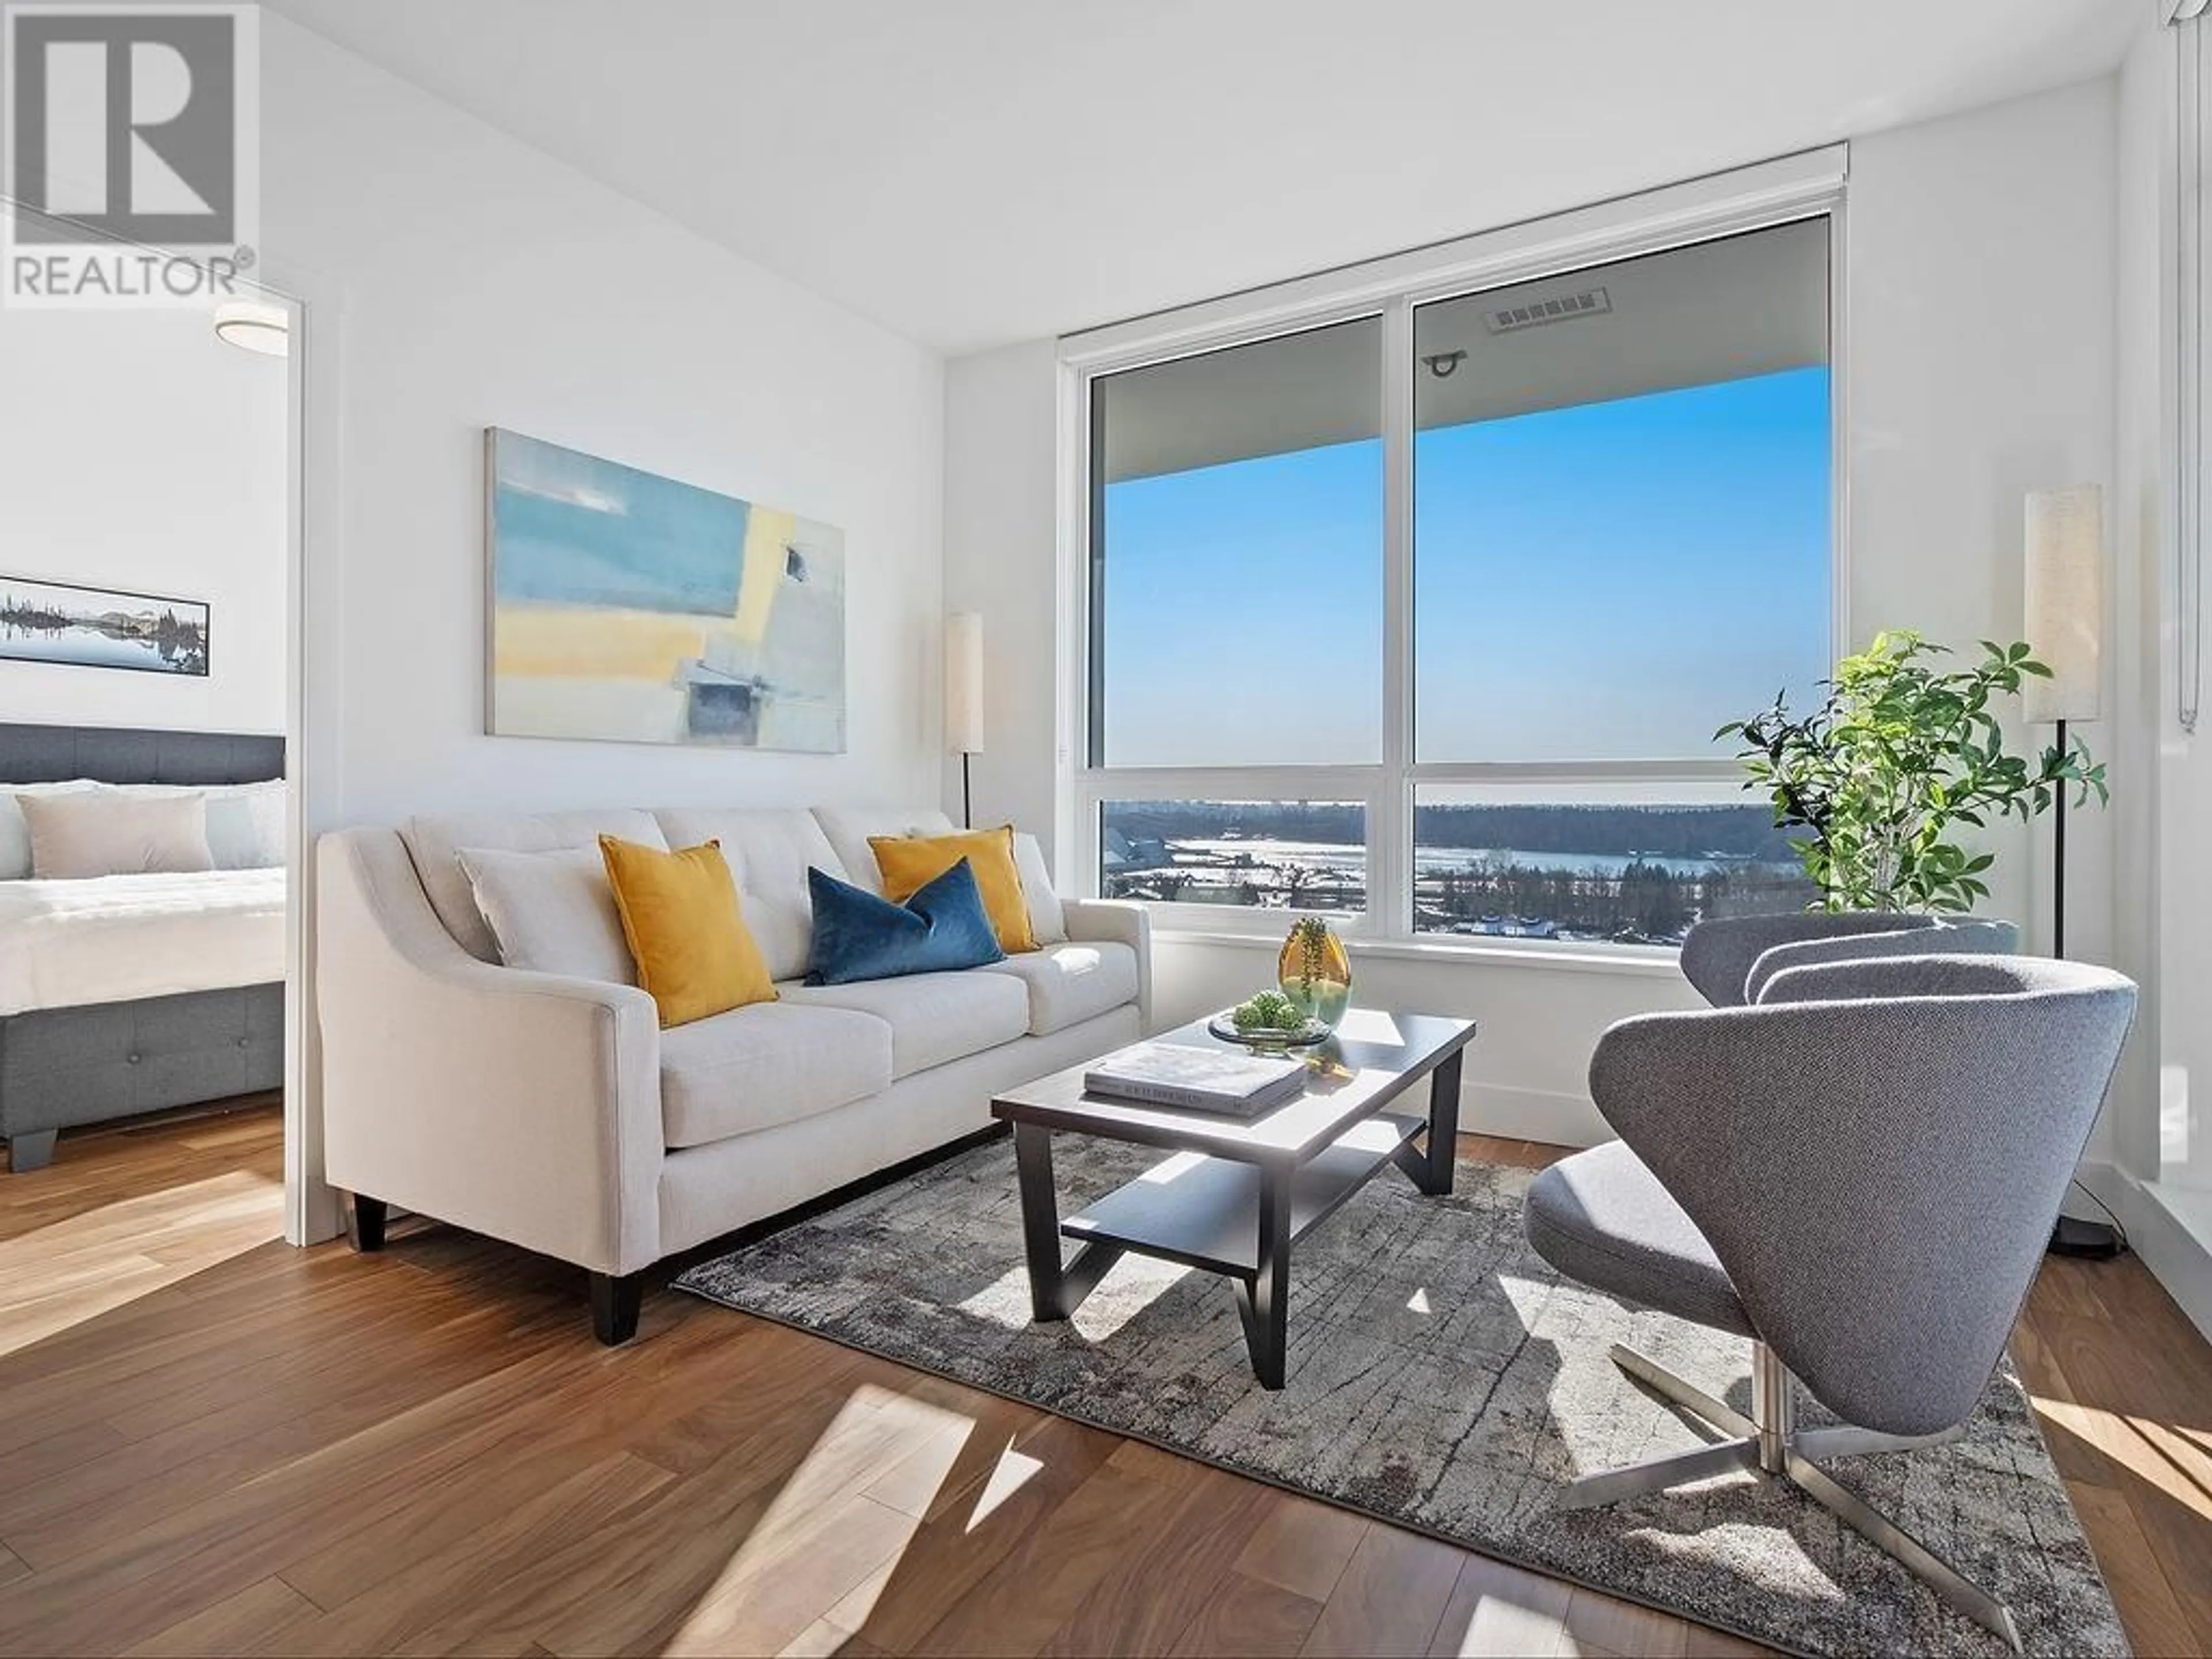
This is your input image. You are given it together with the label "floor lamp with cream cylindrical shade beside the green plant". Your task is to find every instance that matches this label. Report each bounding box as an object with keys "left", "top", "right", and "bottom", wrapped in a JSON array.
[{"left": 2020, "top": 484, "right": 2119, "bottom": 1256}]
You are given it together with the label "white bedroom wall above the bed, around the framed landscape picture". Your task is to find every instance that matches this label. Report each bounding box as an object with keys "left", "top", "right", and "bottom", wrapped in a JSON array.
[{"left": 0, "top": 296, "right": 287, "bottom": 732}]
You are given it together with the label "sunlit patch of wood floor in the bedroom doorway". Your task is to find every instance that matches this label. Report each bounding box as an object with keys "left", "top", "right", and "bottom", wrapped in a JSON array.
[{"left": 0, "top": 1170, "right": 283, "bottom": 1354}]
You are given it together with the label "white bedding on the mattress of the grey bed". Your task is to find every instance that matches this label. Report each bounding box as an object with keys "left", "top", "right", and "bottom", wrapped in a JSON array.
[{"left": 0, "top": 869, "right": 285, "bottom": 1016}]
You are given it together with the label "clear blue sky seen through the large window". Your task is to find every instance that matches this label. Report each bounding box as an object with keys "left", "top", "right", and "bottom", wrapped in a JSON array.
[{"left": 1104, "top": 367, "right": 1832, "bottom": 766}]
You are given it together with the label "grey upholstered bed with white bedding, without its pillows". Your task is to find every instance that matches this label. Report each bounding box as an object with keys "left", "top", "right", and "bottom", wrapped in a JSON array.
[{"left": 0, "top": 724, "right": 285, "bottom": 1172}]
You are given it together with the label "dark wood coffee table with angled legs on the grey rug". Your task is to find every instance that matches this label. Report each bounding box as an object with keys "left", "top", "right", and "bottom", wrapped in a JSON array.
[{"left": 991, "top": 1009, "right": 1475, "bottom": 1389}]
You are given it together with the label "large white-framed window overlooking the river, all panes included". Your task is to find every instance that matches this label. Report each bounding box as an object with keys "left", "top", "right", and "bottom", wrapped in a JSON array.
[{"left": 1077, "top": 214, "right": 1836, "bottom": 945}]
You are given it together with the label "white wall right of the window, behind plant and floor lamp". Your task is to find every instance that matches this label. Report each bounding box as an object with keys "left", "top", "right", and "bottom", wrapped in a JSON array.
[{"left": 1845, "top": 77, "right": 2115, "bottom": 982}]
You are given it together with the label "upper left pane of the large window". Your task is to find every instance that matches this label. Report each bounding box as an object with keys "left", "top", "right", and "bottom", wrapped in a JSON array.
[{"left": 1090, "top": 316, "right": 1382, "bottom": 767}]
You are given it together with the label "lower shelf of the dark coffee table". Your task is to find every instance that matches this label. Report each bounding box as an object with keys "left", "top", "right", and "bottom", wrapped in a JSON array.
[{"left": 1059, "top": 1113, "right": 1429, "bottom": 1279}]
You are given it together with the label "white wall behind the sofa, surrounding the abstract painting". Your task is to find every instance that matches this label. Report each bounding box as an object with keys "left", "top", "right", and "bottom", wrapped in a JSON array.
[{"left": 261, "top": 13, "right": 942, "bottom": 830}]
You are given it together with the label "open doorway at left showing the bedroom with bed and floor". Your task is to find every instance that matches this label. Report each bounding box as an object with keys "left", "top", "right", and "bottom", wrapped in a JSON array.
[{"left": 0, "top": 201, "right": 303, "bottom": 1354}]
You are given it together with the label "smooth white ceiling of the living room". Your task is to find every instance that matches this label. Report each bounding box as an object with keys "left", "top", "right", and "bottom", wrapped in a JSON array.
[{"left": 270, "top": 0, "right": 2137, "bottom": 354}]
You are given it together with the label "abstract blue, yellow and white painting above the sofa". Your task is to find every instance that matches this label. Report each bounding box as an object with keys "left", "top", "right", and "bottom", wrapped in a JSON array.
[{"left": 484, "top": 427, "right": 845, "bottom": 754}]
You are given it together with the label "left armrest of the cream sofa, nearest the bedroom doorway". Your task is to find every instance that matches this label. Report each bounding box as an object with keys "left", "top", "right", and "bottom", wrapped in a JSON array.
[{"left": 316, "top": 830, "right": 664, "bottom": 1274}]
